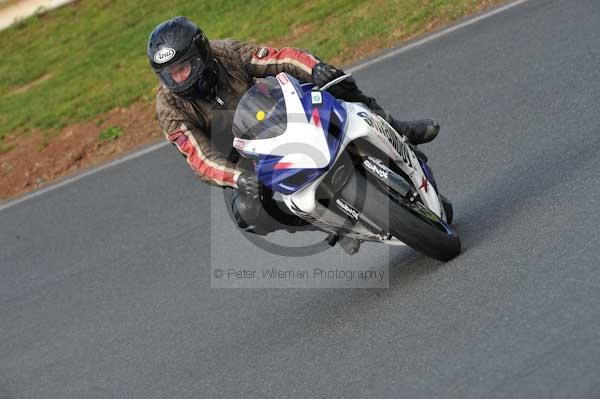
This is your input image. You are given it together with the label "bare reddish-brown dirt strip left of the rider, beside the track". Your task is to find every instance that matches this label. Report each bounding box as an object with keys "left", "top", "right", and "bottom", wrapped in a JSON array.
[{"left": 0, "top": 103, "right": 162, "bottom": 200}]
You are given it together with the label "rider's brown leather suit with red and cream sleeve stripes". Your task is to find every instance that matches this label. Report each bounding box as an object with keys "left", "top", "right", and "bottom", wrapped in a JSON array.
[{"left": 156, "top": 39, "right": 391, "bottom": 234}]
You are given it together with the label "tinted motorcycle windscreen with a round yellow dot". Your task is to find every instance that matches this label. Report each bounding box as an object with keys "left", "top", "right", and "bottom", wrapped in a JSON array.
[{"left": 233, "top": 76, "right": 287, "bottom": 140}]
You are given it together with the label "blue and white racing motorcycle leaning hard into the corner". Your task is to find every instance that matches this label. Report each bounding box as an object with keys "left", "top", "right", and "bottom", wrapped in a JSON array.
[{"left": 233, "top": 73, "right": 461, "bottom": 261}]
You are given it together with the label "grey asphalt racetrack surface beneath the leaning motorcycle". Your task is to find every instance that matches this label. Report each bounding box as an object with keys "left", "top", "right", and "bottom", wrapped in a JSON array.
[{"left": 0, "top": 0, "right": 600, "bottom": 399}]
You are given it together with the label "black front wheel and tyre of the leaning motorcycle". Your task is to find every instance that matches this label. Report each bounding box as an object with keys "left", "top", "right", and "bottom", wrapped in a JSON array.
[{"left": 341, "top": 172, "right": 461, "bottom": 261}]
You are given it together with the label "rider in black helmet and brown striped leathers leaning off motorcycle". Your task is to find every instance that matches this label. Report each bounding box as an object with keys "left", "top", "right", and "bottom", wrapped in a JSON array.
[{"left": 147, "top": 17, "right": 439, "bottom": 254}]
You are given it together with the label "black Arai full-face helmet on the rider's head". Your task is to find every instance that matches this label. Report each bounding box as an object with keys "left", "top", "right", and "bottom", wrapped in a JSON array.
[{"left": 148, "top": 17, "right": 216, "bottom": 98}]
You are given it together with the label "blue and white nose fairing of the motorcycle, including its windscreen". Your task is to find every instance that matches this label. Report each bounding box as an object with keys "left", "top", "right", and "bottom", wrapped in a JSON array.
[{"left": 233, "top": 74, "right": 347, "bottom": 195}]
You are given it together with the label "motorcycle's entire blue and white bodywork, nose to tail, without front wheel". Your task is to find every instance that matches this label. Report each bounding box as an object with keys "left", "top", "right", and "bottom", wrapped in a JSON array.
[{"left": 233, "top": 73, "right": 445, "bottom": 238}]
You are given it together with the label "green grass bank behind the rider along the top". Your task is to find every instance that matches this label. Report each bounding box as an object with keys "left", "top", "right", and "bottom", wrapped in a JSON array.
[{"left": 0, "top": 0, "right": 496, "bottom": 143}]
